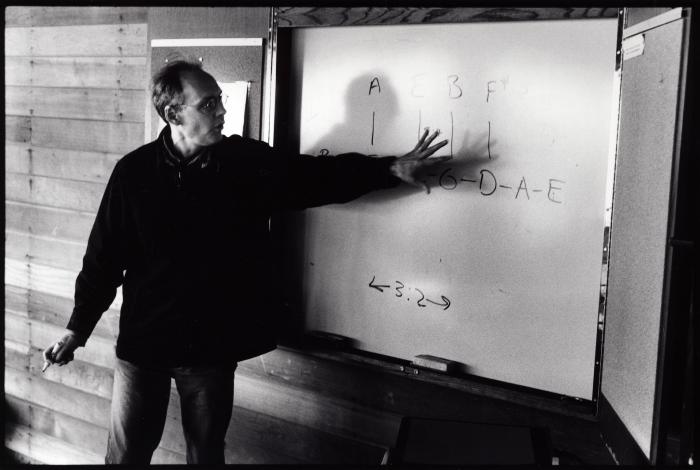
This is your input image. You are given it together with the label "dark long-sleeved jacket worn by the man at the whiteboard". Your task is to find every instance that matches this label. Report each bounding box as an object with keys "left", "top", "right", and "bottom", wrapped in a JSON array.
[{"left": 67, "top": 127, "right": 399, "bottom": 366}]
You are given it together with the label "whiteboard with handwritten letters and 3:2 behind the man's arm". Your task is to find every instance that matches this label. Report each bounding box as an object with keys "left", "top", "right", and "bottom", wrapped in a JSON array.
[{"left": 291, "top": 19, "right": 617, "bottom": 399}]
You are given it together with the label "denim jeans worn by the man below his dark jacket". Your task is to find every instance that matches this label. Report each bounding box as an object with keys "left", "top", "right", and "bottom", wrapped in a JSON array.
[{"left": 105, "top": 359, "right": 236, "bottom": 465}]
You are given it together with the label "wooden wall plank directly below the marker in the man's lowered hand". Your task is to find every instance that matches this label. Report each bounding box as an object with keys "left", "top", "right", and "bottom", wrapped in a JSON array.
[{"left": 5, "top": 360, "right": 110, "bottom": 428}]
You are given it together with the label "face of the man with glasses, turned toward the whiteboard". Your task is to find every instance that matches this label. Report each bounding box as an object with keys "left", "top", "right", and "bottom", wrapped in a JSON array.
[{"left": 178, "top": 72, "right": 226, "bottom": 147}]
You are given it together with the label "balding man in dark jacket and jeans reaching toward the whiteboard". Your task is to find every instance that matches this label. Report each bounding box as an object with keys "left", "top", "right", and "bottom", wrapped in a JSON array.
[{"left": 44, "top": 61, "right": 447, "bottom": 464}]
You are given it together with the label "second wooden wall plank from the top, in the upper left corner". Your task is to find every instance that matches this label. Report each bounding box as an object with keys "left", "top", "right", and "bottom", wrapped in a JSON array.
[{"left": 5, "top": 23, "right": 147, "bottom": 57}]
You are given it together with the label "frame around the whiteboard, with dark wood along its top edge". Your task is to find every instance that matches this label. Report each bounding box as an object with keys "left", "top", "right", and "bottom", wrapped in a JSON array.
[{"left": 261, "top": 7, "right": 623, "bottom": 416}]
